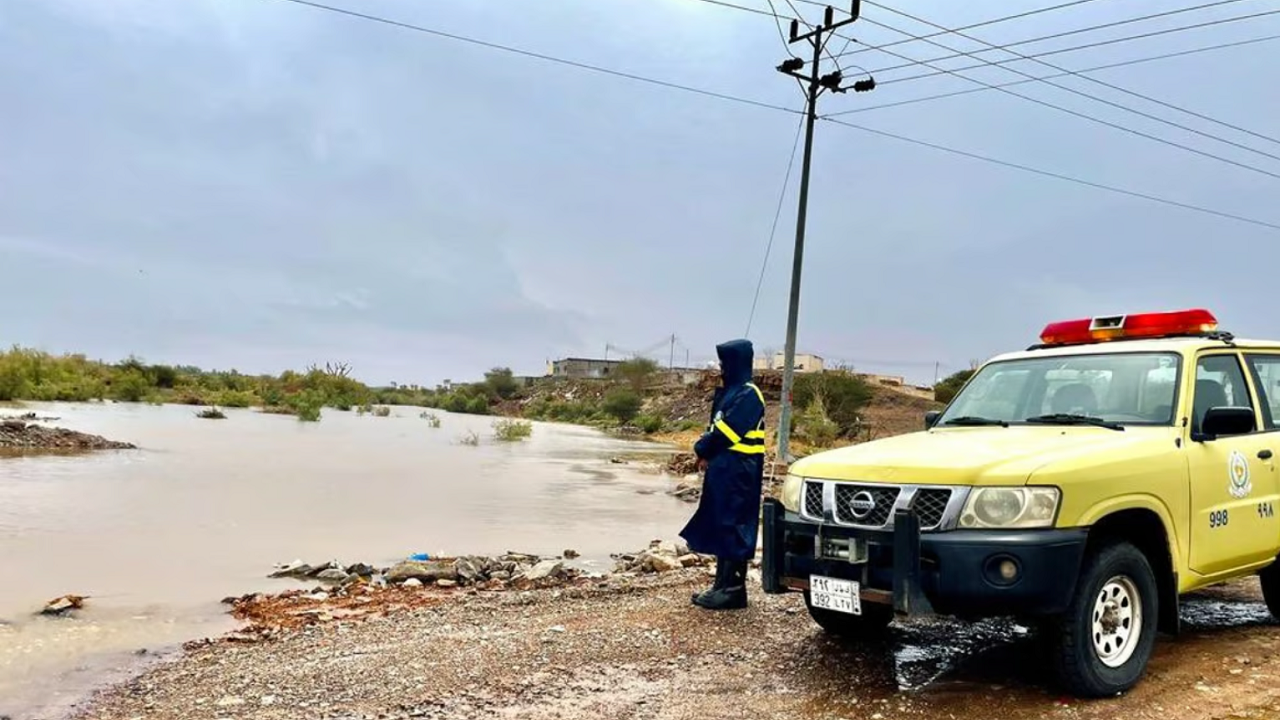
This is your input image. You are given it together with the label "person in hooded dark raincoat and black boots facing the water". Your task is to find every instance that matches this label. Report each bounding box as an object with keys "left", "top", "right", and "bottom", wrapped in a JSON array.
[{"left": 680, "top": 340, "right": 764, "bottom": 610}]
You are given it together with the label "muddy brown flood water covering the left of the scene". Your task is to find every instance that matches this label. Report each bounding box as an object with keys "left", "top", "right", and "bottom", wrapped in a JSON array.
[{"left": 0, "top": 404, "right": 691, "bottom": 719}]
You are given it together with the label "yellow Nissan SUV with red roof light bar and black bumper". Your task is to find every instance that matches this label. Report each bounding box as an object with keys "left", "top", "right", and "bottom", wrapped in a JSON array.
[{"left": 762, "top": 310, "right": 1280, "bottom": 697}]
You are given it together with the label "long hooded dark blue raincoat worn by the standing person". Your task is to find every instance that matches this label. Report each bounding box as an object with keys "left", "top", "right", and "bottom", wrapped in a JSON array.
[{"left": 680, "top": 340, "right": 764, "bottom": 561}]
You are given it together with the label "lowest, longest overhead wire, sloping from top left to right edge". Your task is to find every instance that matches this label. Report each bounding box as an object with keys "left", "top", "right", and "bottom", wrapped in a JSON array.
[{"left": 262, "top": 0, "right": 1280, "bottom": 231}]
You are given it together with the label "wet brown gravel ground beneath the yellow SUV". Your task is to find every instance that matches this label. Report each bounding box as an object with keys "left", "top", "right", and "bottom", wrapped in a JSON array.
[{"left": 72, "top": 571, "right": 1280, "bottom": 720}]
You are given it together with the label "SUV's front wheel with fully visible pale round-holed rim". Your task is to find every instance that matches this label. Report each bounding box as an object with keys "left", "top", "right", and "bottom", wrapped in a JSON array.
[{"left": 1048, "top": 542, "right": 1160, "bottom": 698}]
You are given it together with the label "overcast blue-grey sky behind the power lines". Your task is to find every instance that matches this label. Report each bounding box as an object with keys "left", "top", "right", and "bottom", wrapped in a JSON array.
[{"left": 0, "top": 0, "right": 1280, "bottom": 383}]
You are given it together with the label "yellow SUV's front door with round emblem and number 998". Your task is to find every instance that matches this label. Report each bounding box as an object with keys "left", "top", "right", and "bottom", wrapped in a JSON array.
[{"left": 1187, "top": 352, "right": 1280, "bottom": 575}]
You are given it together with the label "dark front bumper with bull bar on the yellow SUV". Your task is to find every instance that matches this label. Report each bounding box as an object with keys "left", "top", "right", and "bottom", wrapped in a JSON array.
[{"left": 762, "top": 498, "right": 1088, "bottom": 618}]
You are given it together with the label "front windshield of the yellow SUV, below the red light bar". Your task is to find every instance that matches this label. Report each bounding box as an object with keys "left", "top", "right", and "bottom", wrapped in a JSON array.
[{"left": 936, "top": 352, "right": 1181, "bottom": 429}]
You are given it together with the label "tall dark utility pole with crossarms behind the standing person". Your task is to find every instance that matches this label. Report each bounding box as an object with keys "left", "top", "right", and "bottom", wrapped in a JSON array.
[{"left": 777, "top": 0, "right": 876, "bottom": 465}]
